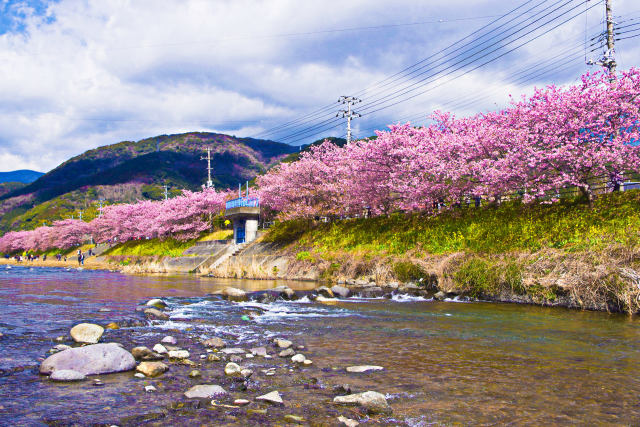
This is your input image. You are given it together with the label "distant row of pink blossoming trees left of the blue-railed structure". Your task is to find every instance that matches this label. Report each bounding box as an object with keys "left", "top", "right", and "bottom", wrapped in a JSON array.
[{"left": 0, "top": 189, "right": 232, "bottom": 253}]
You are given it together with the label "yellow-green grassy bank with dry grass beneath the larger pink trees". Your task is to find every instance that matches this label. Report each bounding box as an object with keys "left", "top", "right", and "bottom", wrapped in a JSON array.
[{"left": 265, "top": 191, "right": 640, "bottom": 312}]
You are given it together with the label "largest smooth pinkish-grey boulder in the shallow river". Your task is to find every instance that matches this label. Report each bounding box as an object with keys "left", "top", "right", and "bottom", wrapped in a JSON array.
[{"left": 40, "top": 343, "right": 136, "bottom": 375}]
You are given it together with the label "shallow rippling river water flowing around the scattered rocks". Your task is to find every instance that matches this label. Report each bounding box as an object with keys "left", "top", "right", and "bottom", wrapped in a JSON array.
[{"left": 0, "top": 266, "right": 640, "bottom": 426}]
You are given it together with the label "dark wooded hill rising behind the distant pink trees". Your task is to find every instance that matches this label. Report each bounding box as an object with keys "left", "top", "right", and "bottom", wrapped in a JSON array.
[{"left": 0, "top": 132, "right": 296, "bottom": 232}]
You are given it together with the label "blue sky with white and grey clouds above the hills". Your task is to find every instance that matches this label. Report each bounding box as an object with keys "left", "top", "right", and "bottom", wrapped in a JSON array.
[{"left": 0, "top": 0, "right": 640, "bottom": 171}]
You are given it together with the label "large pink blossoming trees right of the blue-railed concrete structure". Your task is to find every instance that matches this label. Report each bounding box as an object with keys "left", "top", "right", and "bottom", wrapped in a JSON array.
[{"left": 258, "top": 69, "right": 640, "bottom": 218}]
